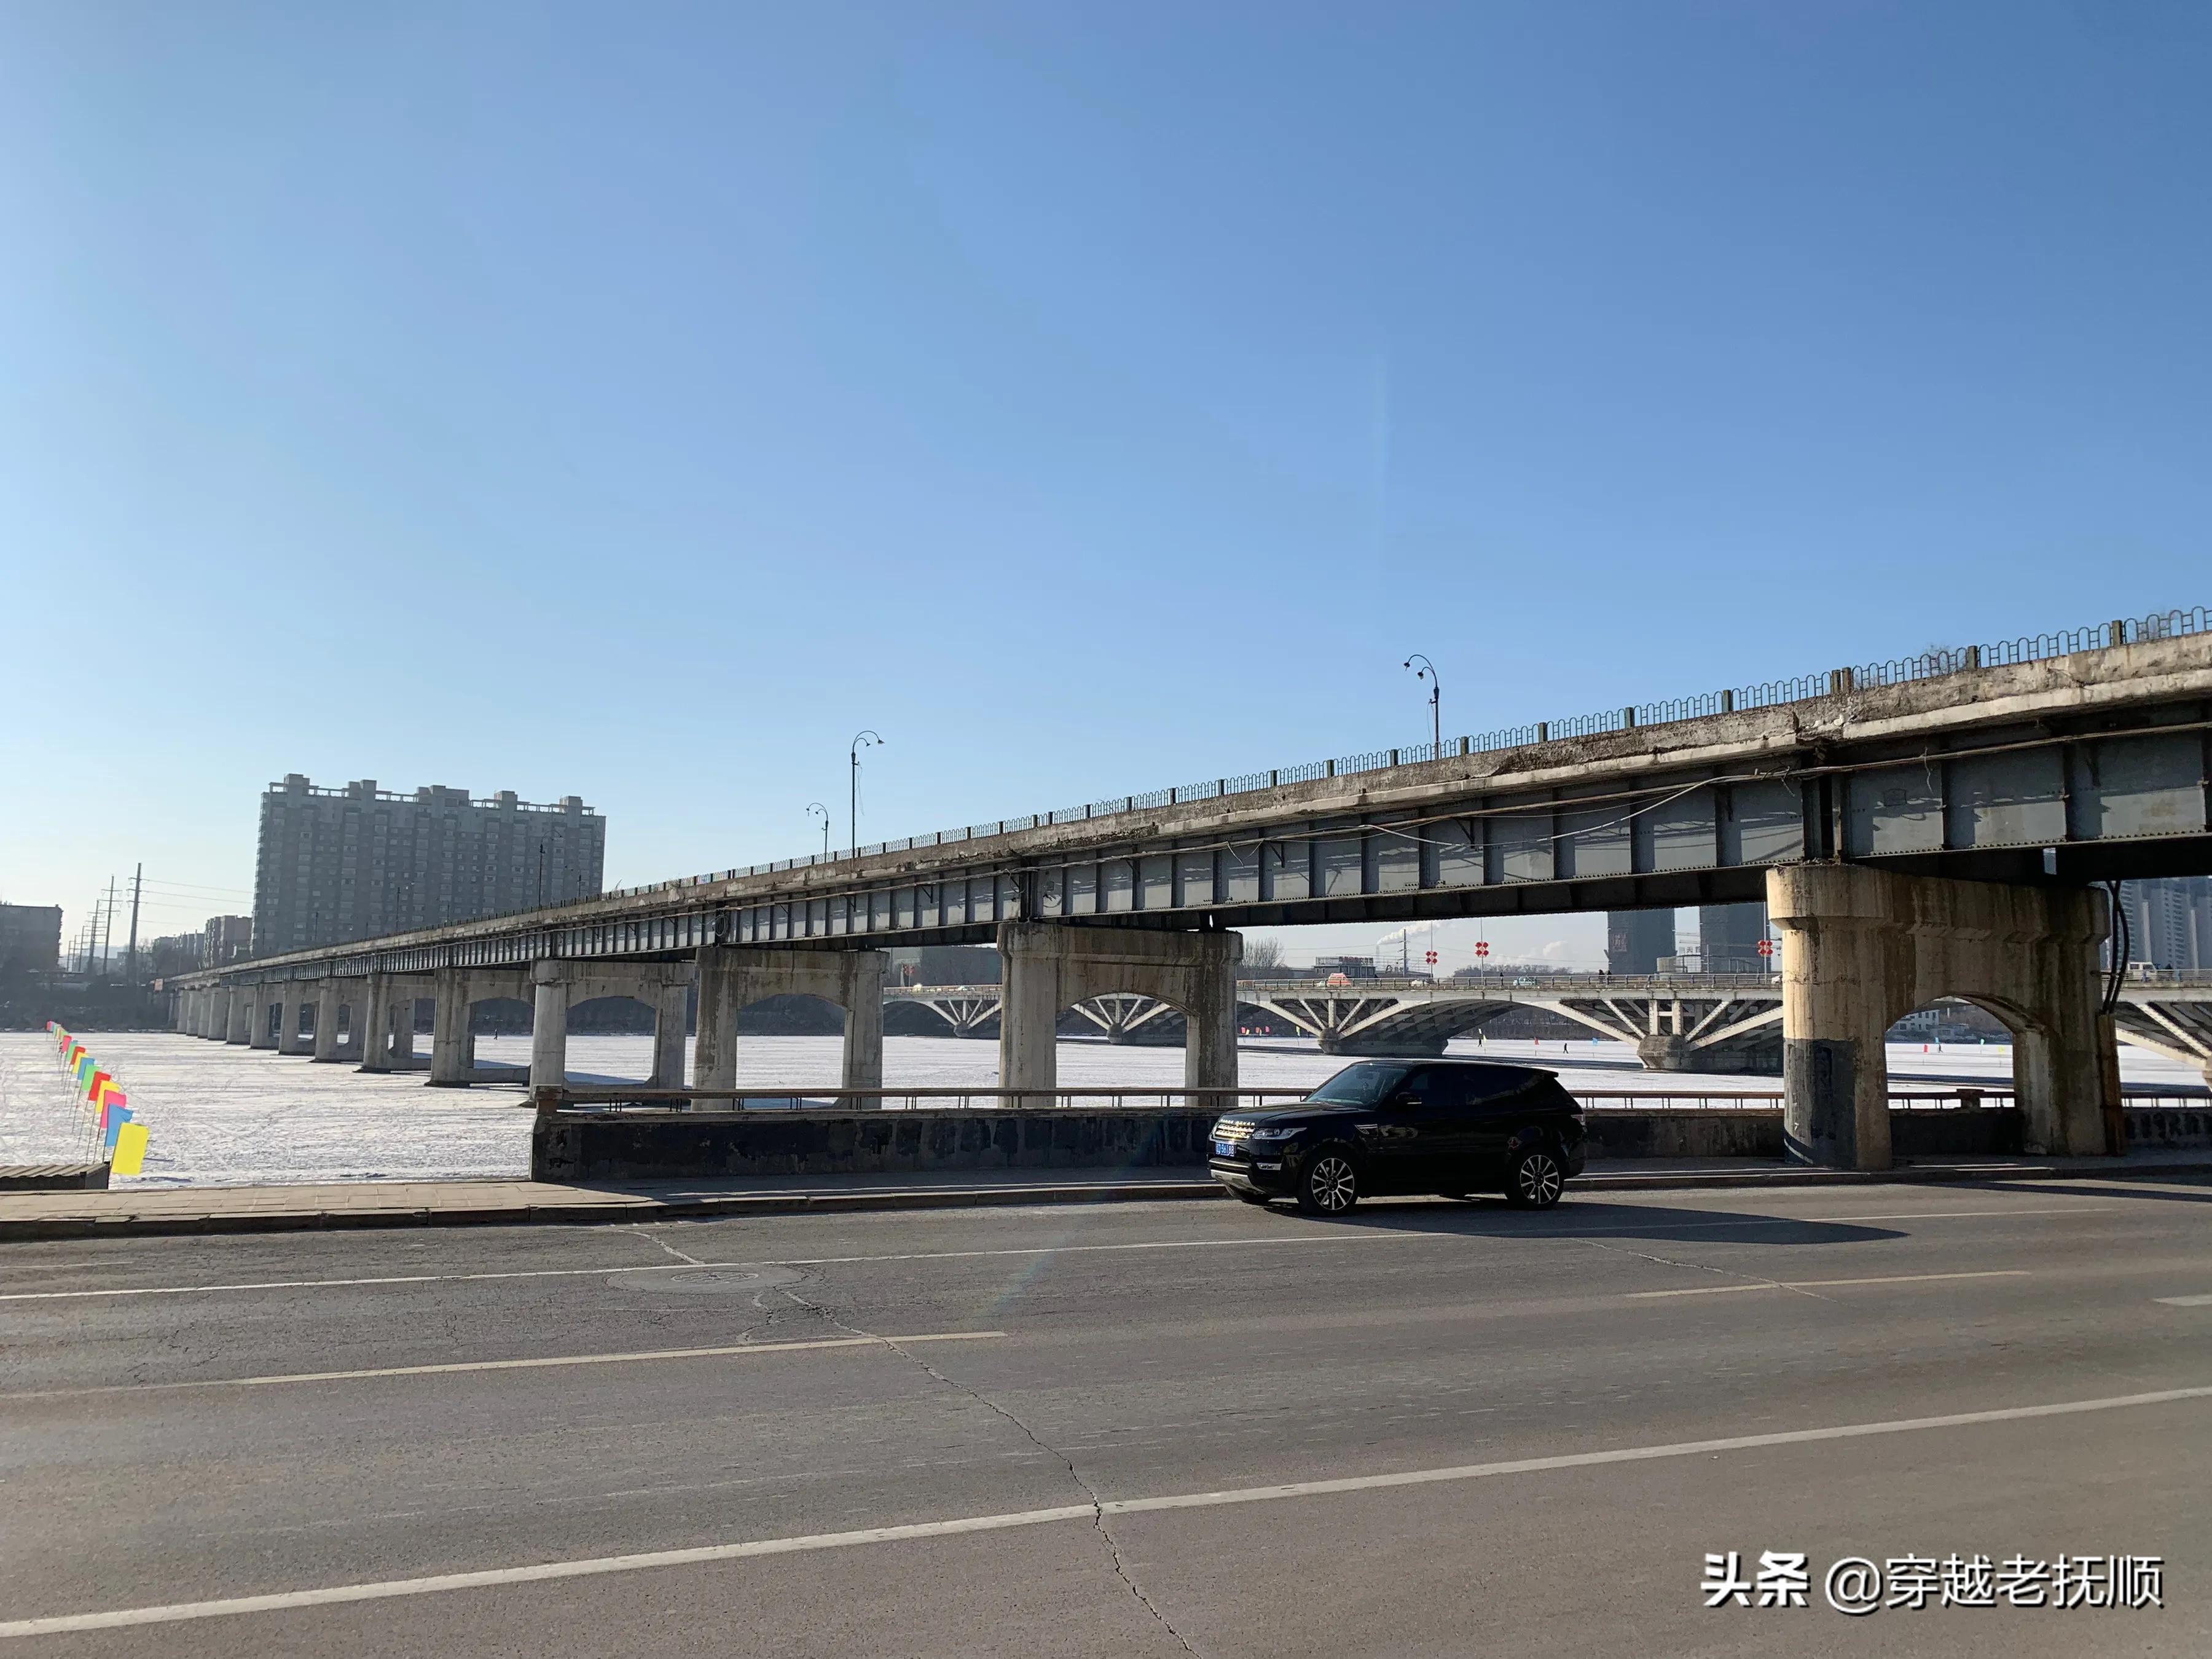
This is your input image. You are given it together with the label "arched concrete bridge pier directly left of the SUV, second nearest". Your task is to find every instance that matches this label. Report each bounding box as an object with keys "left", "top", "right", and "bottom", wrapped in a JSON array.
[{"left": 998, "top": 922, "right": 1243, "bottom": 1106}]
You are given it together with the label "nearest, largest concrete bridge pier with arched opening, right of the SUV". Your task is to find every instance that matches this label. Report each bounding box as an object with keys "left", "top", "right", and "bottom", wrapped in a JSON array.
[{"left": 1767, "top": 865, "right": 2115, "bottom": 1170}]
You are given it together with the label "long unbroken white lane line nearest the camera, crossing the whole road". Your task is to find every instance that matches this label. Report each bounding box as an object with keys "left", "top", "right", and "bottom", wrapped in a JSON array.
[{"left": 0, "top": 1380, "right": 2212, "bottom": 1639}]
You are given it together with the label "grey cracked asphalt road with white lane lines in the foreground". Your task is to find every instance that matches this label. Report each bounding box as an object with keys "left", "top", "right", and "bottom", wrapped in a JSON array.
[{"left": 0, "top": 1181, "right": 2212, "bottom": 1659}]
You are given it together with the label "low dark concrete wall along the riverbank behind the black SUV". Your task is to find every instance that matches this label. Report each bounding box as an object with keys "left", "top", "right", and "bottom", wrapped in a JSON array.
[{"left": 531, "top": 1106, "right": 2070, "bottom": 1181}]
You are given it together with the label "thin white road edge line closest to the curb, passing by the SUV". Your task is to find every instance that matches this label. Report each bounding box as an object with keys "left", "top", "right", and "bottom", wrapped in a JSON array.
[{"left": 0, "top": 1203, "right": 2117, "bottom": 1303}]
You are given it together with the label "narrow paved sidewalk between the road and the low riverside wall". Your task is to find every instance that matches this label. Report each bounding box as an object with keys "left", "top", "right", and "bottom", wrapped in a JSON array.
[{"left": 0, "top": 1153, "right": 2212, "bottom": 1241}]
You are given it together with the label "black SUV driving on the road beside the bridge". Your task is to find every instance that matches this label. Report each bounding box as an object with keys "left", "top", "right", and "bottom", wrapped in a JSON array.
[{"left": 1208, "top": 1059, "right": 1584, "bottom": 1214}]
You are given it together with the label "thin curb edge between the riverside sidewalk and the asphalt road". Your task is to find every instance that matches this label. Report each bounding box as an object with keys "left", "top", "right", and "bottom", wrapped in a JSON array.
[{"left": 0, "top": 1159, "right": 2212, "bottom": 1243}]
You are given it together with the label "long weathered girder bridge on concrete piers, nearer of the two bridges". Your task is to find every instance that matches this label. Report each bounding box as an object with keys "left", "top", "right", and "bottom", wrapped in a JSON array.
[{"left": 181, "top": 608, "right": 2212, "bottom": 1168}]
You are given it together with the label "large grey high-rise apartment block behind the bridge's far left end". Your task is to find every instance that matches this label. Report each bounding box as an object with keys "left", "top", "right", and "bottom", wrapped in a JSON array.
[{"left": 254, "top": 772, "right": 606, "bottom": 955}]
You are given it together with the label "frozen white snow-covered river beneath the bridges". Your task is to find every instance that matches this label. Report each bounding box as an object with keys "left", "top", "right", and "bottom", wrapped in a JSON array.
[{"left": 0, "top": 1031, "right": 2203, "bottom": 1186}]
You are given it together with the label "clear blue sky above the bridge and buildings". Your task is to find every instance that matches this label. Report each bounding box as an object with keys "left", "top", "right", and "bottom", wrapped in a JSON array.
[{"left": 0, "top": 0, "right": 2212, "bottom": 968}]
